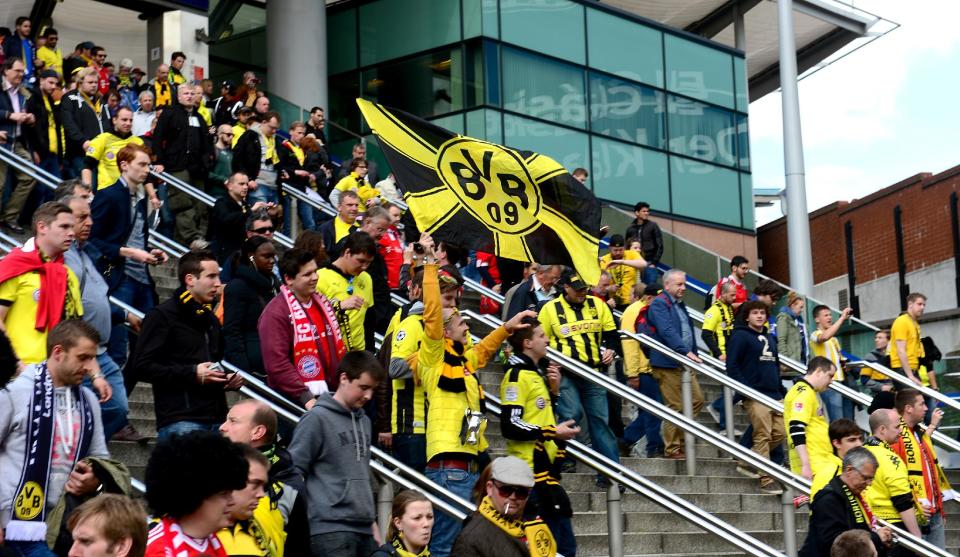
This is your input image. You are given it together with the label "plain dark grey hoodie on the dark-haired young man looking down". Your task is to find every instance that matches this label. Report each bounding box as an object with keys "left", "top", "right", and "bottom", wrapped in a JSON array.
[{"left": 289, "top": 393, "right": 376, "bottom": 536}]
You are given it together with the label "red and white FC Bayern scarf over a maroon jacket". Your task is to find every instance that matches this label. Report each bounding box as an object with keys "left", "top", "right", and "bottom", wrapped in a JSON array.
[{"left": 280, "top": 286, "right": 347, "bottom": 396}]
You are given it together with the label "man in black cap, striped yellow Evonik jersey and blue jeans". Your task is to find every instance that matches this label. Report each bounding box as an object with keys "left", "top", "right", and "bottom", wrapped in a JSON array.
[{"left": 540, "top": 269, "right": 620, "bottom": 480}]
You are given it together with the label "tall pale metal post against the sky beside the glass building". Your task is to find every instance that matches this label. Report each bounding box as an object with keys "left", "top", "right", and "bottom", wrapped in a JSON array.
[{"left": 777, "top": 0, "right": 813, "bottom": 295}]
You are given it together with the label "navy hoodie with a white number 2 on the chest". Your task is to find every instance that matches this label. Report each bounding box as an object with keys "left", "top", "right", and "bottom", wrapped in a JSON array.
[{"left": 727, "top": 323, "right": 785, "bottom": 400}]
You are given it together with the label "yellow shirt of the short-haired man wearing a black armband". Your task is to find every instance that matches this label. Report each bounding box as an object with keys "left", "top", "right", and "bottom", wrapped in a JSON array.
[{"left": 783, "top": 379, "right": 836, "bottom": 474}]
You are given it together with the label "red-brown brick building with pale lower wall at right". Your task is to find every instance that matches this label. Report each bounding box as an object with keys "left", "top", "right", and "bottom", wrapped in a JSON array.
[{"left": 757, "top": 166, "right": 960, "bottom": 352}]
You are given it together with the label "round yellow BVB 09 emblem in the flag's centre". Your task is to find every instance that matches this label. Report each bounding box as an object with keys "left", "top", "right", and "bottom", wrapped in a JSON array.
[{"left": 437, "top": 137, "right": 542, "bottom": 234}]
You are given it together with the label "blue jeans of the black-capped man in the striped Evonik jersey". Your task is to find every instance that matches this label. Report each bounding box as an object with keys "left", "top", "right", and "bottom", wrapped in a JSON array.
[{"left": 557, "top": 372, "right": 620, "bottom": 470}]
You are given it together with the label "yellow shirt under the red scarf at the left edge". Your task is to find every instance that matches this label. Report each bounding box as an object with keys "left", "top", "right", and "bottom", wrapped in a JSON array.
[{"left": 0, "top": 267, "right": 83, "bottom": 364}]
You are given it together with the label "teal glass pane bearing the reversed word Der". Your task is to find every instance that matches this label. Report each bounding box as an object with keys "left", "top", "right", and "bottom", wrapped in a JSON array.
[{"left": 667, "top": 95, "right": 737, "bottom": 166}]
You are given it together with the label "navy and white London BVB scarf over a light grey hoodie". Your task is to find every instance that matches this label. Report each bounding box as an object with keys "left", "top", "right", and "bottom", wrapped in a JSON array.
[{"left": 6, "top": 362, "right": 94, "bottom": 541}]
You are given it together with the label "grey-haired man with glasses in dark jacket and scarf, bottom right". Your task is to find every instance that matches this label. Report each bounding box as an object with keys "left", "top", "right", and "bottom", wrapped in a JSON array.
[{"left": 798, "top": 447, "right": 893, "bottom": 557}]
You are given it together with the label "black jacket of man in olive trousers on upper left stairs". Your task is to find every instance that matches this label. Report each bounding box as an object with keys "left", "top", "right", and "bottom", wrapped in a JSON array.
[{"left": 153, "top": 104, "right": 213, "bottom": 178}]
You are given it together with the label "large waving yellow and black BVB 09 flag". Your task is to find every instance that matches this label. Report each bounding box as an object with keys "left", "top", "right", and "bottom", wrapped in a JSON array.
[{"left": 357, "top": 99, "right": 600, "bottom": 284}]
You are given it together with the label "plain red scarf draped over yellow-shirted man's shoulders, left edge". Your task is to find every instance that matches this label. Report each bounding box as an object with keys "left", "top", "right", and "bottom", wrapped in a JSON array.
[{"left": 0, "top": 243, "right": 67, "bottom": 331}]
